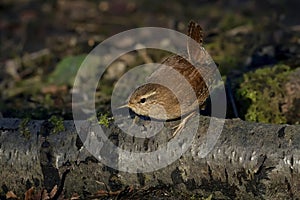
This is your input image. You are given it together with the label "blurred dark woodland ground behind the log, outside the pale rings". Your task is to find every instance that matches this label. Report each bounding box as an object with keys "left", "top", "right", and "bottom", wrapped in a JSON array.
[{"left": 0, "top": 0, "right": 300, "bottom": 124}]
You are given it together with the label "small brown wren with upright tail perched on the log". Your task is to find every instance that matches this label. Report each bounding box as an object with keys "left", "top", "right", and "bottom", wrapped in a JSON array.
[{"left": 127, "top": 21, "right": 216, "bottom": 136}]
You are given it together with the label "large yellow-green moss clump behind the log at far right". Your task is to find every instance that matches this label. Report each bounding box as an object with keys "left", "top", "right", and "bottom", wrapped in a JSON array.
[{"left": 237, "top": 65, "right": 291, "bottom": 124}]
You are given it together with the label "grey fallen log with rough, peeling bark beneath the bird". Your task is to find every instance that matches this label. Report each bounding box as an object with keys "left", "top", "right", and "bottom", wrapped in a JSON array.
[{"left": 0, "top": 116, "right": 300, "bottom": 199}]
